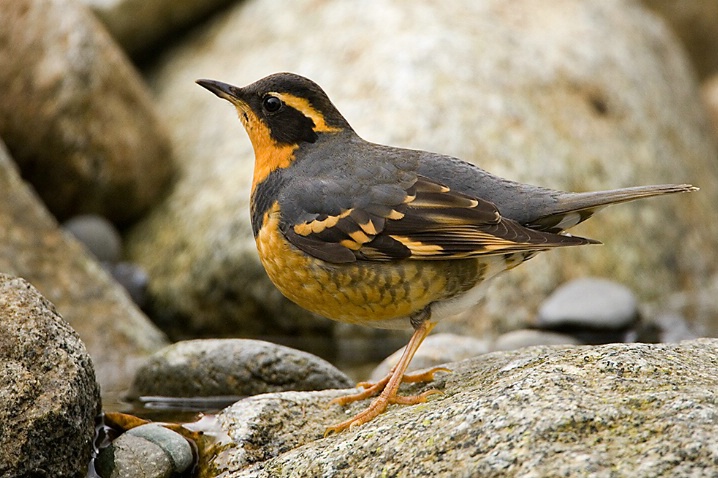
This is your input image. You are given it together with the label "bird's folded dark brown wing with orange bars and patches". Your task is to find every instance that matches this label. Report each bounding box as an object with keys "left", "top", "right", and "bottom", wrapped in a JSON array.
[{"left": 285, "top": 176, "right": 596, "bottom": 263}]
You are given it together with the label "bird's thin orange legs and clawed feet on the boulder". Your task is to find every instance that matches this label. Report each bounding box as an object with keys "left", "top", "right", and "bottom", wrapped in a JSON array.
[{"left": 325, "top": 309, "right": 446, "bottom": 435}]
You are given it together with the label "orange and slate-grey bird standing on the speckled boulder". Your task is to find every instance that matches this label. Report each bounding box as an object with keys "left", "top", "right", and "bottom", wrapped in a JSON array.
[{"left": 196, "top": 72, "right": 698, "bottom": 434}]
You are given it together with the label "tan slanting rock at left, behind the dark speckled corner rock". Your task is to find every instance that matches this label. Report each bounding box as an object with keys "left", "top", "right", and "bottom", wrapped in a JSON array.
[{"left": 0, "top": 137, "right": 167, "bottom": 397}]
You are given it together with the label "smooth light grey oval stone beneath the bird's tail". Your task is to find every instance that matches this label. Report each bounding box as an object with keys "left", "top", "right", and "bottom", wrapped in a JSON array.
[{"left": 537, "top": 277, "right": 638, "bottom": 330}]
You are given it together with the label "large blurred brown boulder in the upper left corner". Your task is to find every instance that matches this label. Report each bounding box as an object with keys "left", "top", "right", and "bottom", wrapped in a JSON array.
[{"left": 0, "top": 0, "right": 173, "bottom": 222}]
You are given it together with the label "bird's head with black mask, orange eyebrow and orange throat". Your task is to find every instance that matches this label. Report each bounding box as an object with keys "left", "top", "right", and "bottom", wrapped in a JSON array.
[{"left": 197, "top": 73, "right": 350, "bottom": 151}]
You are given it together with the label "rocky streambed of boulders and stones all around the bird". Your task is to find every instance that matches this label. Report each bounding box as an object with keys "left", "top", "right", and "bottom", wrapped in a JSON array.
[{"left": 0, "top": 0, "right": 718, "bottom": 478}]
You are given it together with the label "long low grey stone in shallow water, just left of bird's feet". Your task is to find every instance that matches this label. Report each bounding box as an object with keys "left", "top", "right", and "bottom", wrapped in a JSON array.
[{"left": 129, "top": 339, "right": 352, "bottom": 398}]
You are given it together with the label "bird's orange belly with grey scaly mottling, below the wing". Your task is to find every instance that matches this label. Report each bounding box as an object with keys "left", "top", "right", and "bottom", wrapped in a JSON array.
[{"left": 256, "top": 203, "right": 490, "bottom": 326}]
